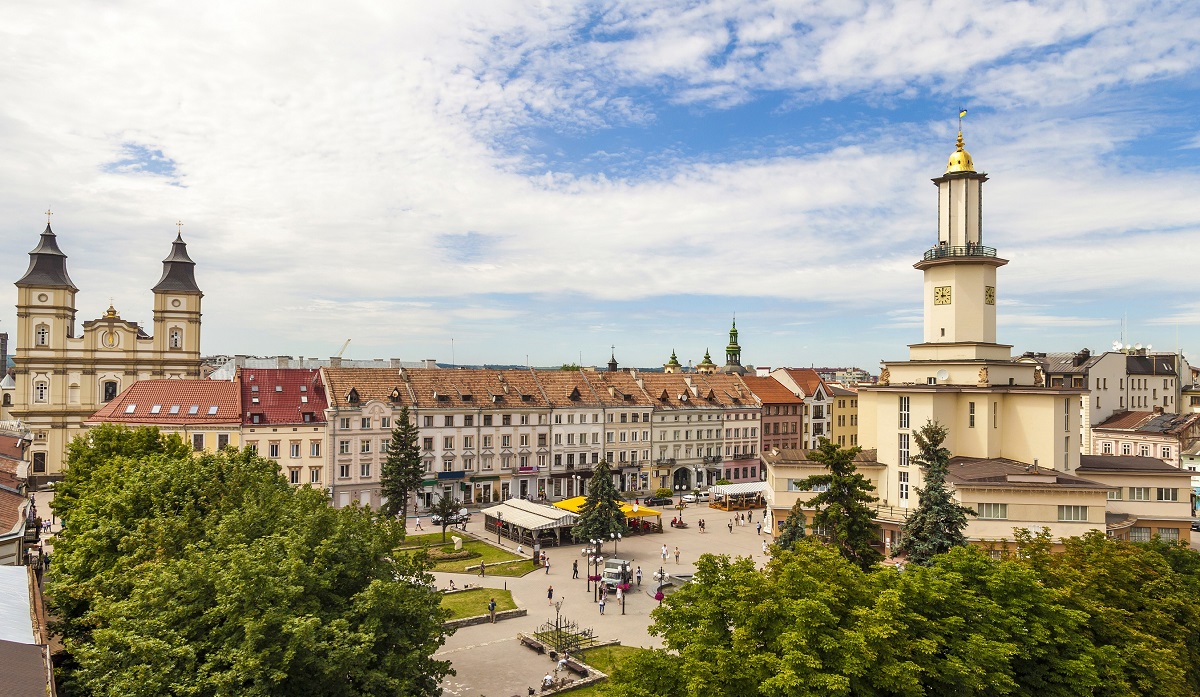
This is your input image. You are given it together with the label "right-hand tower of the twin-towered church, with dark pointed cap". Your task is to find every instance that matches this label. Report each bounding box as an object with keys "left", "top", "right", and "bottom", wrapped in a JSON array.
[{"left": 152, "top": 234, "right": 204, "bottom": 356}]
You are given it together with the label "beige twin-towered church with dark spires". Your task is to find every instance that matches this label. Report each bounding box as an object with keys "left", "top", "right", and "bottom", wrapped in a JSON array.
[{"left": 10, "top": 224, "right": 204, "bottom": 486}]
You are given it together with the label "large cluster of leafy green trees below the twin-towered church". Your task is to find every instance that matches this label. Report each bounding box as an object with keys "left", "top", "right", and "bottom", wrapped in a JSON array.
[{"left": 47, "top": 426, "right": 450, "bottom": 697}]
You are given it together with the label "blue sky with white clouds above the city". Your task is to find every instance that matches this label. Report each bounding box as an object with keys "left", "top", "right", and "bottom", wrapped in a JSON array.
[{"left": 0, "top": 0, "right": 1200, "bottom": 372}]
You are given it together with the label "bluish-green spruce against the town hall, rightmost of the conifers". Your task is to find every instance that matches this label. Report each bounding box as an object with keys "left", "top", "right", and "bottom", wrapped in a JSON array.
[{"left": 894, "top": 421, "right": 976, "bottom": 566}]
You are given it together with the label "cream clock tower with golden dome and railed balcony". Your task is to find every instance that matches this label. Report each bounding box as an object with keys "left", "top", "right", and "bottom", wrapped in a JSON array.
[{"left": 910, "top": 131, "right": 1012, "bottom": 360}]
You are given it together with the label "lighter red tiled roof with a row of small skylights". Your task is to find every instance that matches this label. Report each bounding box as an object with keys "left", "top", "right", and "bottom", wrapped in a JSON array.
[{"left": 86, "top": 380, "right": 241, "bottom": 426}]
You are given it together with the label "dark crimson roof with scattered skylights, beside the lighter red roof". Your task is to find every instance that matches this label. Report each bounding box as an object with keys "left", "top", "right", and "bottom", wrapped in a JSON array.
[{"left": 234, "top": 368, "right": 328, "bottom": 423}]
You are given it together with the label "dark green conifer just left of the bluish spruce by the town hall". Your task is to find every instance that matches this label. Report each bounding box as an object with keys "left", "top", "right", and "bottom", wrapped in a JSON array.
[{"left": 799, "top": 438, "right": 883, "bottom": 570}]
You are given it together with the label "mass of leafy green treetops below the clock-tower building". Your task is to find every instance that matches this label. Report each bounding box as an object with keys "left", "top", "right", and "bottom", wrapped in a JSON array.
[{"left": 608, "top": 533, "right": 1200, "bottom": 697}]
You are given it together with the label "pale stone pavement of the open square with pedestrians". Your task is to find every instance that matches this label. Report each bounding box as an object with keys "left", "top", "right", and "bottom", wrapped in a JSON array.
[{"left": 429, "top": 504, "right": 770, "bottom": 697}]
